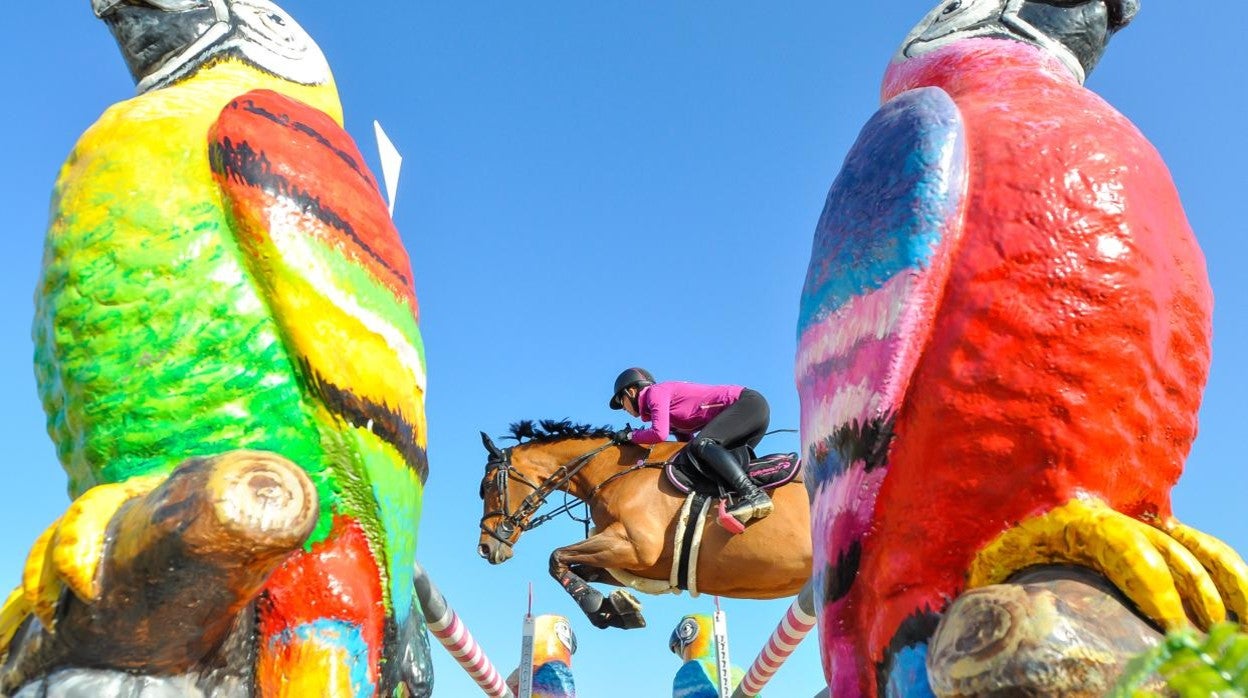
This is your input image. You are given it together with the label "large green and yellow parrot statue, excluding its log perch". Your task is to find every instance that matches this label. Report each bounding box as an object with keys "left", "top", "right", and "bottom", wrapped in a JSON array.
[{"left": 5, "top": 0, "right": 431, "bottom": 698}]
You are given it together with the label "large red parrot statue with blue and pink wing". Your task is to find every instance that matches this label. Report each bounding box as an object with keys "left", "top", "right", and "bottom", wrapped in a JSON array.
[{"left": 796, "top": 0, "right": 1248, "bottom": 697}]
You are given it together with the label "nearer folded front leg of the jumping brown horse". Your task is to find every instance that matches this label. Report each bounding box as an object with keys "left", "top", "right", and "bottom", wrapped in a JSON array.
[{"left": 550, "top": 524, "right": 645, "bottom": 629}]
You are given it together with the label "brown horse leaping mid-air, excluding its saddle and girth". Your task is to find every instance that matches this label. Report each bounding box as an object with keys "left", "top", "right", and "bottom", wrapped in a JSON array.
[{"left": 478, "top": 422, "right": 811, "bottom": 628}]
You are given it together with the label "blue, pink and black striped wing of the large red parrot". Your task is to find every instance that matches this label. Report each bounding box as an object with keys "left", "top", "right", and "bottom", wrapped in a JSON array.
[{"left": 796, "top": 87, "right": 967, "bottom": 696}]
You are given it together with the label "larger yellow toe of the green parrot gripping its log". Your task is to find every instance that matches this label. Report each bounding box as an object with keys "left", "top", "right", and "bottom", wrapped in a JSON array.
[{"left": 51, "top": 474, "right": 165, "bottom": 602}]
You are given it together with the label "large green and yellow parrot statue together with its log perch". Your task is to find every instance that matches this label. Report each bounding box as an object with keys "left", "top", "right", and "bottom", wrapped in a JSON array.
[{"left": 0, "top": 0, "right": 432, "bottom": 697}]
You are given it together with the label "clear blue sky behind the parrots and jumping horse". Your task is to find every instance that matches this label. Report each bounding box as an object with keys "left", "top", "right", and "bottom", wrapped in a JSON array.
[{"left": 0, "top": 0, "right": 1248, "bottom": 698}]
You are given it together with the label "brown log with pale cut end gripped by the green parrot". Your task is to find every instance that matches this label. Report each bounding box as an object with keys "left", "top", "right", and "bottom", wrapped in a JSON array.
[{"left": 0, "top": 451, "right": 318, "bottom": 694}]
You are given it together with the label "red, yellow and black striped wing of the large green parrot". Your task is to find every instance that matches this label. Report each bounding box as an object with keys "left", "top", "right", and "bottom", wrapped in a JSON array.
[{"left": 208, "top": 90, "right": 427, "bottom": 479}]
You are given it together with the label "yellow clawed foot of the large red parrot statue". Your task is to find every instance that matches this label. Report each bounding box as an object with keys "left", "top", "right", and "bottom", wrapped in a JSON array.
[{"left": 967, "top": 499, "right": 1218, "bottom": 631}]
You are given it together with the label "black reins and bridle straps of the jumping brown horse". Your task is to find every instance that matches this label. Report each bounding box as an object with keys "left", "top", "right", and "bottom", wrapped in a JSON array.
[{"left": 480, "top": 441, "right": 660, "bottom": 546}]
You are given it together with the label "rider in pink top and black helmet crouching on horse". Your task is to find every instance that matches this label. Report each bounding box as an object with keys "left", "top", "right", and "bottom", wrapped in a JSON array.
[{"left": 608, "top": 367, "right": 771, "bottom": 523}]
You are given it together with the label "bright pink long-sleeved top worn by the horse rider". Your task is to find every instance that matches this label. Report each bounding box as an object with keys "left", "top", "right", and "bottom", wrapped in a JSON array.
[{"left": 631, "top": 381, "right": 745, "bottom": 443}]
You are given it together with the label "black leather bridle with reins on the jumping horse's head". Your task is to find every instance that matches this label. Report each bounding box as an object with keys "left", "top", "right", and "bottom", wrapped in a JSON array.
[{"left": 480, "top": 433, "right": 650, "bottom": 547}]
